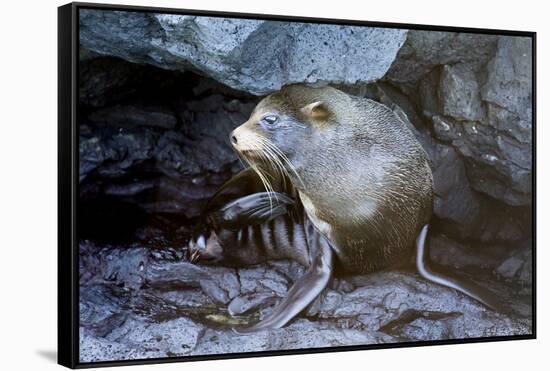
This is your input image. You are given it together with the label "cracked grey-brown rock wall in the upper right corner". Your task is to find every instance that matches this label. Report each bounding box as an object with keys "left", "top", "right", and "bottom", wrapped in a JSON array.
[{"left": 386, "top": 31, "right": 532, "bottom": 206}]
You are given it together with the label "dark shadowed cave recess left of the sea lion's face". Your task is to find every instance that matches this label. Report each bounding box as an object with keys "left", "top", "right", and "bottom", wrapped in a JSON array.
[{"left": 77, "top": 57, "right": 258, "bottom": 246}]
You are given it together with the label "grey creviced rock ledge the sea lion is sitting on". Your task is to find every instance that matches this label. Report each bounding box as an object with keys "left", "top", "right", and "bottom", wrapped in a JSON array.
[{"left": 80, "top": 241, "right": 531, "bottom": 362}]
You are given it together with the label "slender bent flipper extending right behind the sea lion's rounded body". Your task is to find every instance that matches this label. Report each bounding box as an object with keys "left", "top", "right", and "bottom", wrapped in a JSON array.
[{"left": 416, "top": 224, "right": 507, "bottom": 312}]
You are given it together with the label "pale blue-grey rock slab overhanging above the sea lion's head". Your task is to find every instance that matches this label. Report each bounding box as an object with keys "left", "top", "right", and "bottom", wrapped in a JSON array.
[{"left": 80, "top": 10, "right": 406, "bottom": 95}]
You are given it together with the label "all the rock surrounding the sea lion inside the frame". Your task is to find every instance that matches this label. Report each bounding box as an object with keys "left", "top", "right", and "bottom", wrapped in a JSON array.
[{"left": 78, "top": 10, "right": 532, "bottom": 362}]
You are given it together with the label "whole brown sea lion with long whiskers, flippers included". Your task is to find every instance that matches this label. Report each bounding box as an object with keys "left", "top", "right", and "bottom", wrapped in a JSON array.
[{"left": 190, "top": 85, "right": 502, "bottom": 332}]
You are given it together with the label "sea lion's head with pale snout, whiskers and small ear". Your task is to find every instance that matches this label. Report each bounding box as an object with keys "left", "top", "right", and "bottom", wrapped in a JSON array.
[{"left": 230, "top": 85, "right": 344, "bottom": 187}]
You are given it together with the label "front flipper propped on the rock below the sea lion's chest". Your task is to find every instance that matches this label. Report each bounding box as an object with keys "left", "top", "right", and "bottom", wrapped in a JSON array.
[{"left": 233, "top": 233, "right": 334, "bottom": 334}]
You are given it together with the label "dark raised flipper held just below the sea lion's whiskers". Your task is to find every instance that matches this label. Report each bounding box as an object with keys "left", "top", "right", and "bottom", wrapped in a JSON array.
[{"left": 209, "top": 192, "right": 294, "bottom": 229}]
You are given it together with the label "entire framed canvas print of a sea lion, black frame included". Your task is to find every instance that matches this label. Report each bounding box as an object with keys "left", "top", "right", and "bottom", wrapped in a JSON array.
[{"left": 58, "top": 3, "right": 536, "bottom": 368}]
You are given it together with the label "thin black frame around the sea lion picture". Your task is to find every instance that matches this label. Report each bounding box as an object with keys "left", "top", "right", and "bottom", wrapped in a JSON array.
[{"left": 58, "top": 3, "right": 537, "bottom": 368}]
